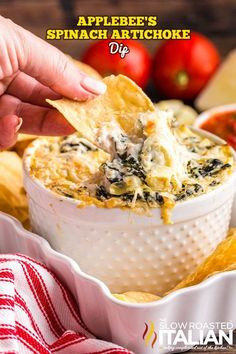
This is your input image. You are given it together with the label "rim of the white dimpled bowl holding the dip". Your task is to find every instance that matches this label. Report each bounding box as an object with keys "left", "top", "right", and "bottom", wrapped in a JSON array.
[{"left": 23, "top": 128, "right": 236, "bottom": 212}]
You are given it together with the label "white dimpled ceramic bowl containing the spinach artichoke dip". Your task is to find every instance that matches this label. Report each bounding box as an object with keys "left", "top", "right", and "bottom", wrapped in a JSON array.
[{"left": 24, "top": 131, "right": 236, "bottom": 295}]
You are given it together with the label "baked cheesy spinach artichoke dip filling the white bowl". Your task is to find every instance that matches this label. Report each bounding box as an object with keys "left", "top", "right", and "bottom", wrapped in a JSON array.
[{"left": 31, "top": 110, "right": 235, "bottom": 223}]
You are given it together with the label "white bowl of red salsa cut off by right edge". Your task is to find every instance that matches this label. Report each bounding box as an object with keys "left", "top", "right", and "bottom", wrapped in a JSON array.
[{"left": 195, "top": 103, "right": 236, "bottom": 150}]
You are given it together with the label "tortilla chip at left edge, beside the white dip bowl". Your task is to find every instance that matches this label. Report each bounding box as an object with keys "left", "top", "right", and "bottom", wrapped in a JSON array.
[{"left": 0, "top": 151, "right": 28, "bottom": 222}]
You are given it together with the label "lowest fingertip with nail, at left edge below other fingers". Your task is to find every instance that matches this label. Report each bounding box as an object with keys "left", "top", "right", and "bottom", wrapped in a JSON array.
[{"left": 0, "top": 114, "right": 22, "bottom": 149}]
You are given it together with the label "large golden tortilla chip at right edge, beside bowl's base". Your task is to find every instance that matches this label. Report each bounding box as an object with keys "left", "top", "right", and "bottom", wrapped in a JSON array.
[{"left": 170, "top": 228, "right": 236, "bottom": 292}]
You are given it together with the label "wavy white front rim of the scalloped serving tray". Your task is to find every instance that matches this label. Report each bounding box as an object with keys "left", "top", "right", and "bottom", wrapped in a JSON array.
[{"left": 3, "top": 212, "right": 236, "bottom": 310}]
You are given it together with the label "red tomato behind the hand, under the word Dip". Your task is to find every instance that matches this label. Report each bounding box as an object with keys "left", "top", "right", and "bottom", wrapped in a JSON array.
[{"left": 82, "top": 39, "right": 151, "bottom": 88}]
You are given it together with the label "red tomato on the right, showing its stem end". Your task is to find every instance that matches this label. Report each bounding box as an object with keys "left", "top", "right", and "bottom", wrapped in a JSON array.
[{"left": 153, "top": 32, "right": 220, "bottom": 100}]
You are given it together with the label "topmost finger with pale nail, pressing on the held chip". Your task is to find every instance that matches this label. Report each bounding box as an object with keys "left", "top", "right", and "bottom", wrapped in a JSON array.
[{"left": 15, "top": 20, "right": 106, "bottom": 100}]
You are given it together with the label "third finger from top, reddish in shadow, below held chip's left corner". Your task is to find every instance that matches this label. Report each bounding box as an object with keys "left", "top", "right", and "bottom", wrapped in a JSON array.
[{"left": 0, "top": 95, "right": 74, "bottom": 136}]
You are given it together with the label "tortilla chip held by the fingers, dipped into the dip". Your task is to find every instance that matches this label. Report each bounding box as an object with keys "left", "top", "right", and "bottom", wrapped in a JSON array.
[{"left": 46, "top": 75, "right": 155, "bottom": 145}]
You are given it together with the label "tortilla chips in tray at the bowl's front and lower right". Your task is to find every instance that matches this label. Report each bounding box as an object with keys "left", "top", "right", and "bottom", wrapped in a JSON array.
[{"left": 113, "top": 228, "right": 236, "bottom": 303}]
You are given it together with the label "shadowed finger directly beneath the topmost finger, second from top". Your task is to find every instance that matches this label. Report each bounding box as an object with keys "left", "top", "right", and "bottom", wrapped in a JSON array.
[{"left": 6, "top": 72, "right": 61, "bottom": 107}]
